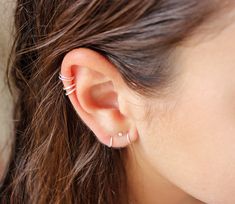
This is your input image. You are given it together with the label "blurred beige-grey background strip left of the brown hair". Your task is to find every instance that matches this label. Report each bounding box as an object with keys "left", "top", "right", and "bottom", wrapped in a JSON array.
[{"left": 0, "top": 0, "right": 15, "bottom": 176}]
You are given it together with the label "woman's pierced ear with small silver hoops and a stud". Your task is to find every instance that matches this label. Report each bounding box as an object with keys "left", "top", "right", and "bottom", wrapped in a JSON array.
[{"left": 61, "top": 48, "right": 137, "bottom": 147}]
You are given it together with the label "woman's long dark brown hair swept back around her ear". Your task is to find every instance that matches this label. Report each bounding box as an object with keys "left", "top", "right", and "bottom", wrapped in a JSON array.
[{"left": 0, "top": 0, "right": 217, "bottom": 204}]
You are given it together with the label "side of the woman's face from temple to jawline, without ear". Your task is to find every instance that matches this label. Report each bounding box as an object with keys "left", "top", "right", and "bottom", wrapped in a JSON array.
[{"left": 129, "top": 7, "right": 235, "bottom": 204}]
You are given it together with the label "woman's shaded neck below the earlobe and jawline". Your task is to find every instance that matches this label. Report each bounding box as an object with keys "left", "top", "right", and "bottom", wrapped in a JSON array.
[{"left": 124, "top": 149, "right": 203, "bottom": 204}]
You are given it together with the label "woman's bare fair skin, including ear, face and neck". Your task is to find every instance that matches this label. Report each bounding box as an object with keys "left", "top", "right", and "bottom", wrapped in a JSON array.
[{"left": 61, "top": 3, "right": 235, "bottom": 204}]
